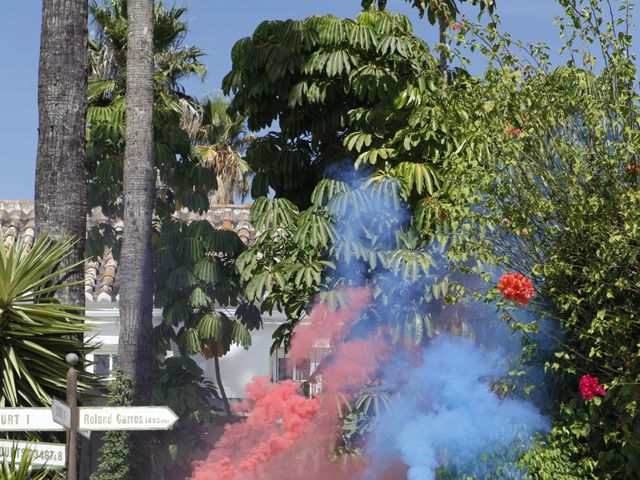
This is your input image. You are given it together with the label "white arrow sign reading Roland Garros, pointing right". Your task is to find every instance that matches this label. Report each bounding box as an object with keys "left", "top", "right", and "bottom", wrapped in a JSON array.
[{"left": 79, "top": 407, "right": 178, "bottom": 432}]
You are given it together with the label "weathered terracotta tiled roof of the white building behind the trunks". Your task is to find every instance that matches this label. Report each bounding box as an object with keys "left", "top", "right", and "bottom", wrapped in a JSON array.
[{"left": 0, "top": 200, "right": 255, "bottom": 302}]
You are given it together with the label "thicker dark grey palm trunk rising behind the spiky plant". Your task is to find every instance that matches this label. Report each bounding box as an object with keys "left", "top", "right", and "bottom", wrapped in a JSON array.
[{"left": 35, "top": 0, "right": 88, "bottom": 307}]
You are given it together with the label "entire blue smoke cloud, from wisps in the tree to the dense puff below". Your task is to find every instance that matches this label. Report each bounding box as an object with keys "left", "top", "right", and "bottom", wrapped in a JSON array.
[{"left": 316, "top": 165, "right": 549, "bottom": 480}]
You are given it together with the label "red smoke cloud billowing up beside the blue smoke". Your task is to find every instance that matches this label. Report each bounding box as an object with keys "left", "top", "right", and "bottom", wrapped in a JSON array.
[{"left": 191, "top": 288, "right": 388, "bottom": 480}]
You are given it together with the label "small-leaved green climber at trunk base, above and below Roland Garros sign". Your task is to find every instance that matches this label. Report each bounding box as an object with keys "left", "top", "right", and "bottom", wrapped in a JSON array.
[{"left": 91, "top": 369, "right": 133, "bottom": 480}]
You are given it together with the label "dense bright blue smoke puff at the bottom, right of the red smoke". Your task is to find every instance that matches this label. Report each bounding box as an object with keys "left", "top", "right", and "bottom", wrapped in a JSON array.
[{"left": 365, "top": 335, "right": 549, "bottom": 480}]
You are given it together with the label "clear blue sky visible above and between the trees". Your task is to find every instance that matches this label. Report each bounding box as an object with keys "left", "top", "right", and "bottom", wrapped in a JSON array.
[{"left": 0, "top": 0, "right": 561, "bottom": 199}]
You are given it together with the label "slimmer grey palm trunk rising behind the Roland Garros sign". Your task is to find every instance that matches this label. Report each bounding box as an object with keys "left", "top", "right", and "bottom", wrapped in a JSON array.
[{"left": 118, "top": 0, "right": 155, "bottom": 478}]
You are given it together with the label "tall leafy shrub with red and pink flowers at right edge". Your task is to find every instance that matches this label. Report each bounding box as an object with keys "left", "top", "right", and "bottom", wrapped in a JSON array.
[{"left": 451, "top": 0, "right": 640, "bottom": 479}]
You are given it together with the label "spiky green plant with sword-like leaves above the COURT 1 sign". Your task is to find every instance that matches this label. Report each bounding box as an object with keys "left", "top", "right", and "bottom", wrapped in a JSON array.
[{"left": 0, "top": 236, "right": 90, "bottom": 407}]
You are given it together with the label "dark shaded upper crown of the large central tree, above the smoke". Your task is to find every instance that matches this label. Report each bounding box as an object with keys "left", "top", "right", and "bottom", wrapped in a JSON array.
[{"left": 223, "top": 11, "right": 441, "bottom": 208}]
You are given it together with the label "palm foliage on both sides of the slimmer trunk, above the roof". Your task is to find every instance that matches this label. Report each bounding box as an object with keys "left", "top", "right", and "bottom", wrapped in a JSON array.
[{"left": 87, "top": 0, "right": 216, "bottom": 237}]
